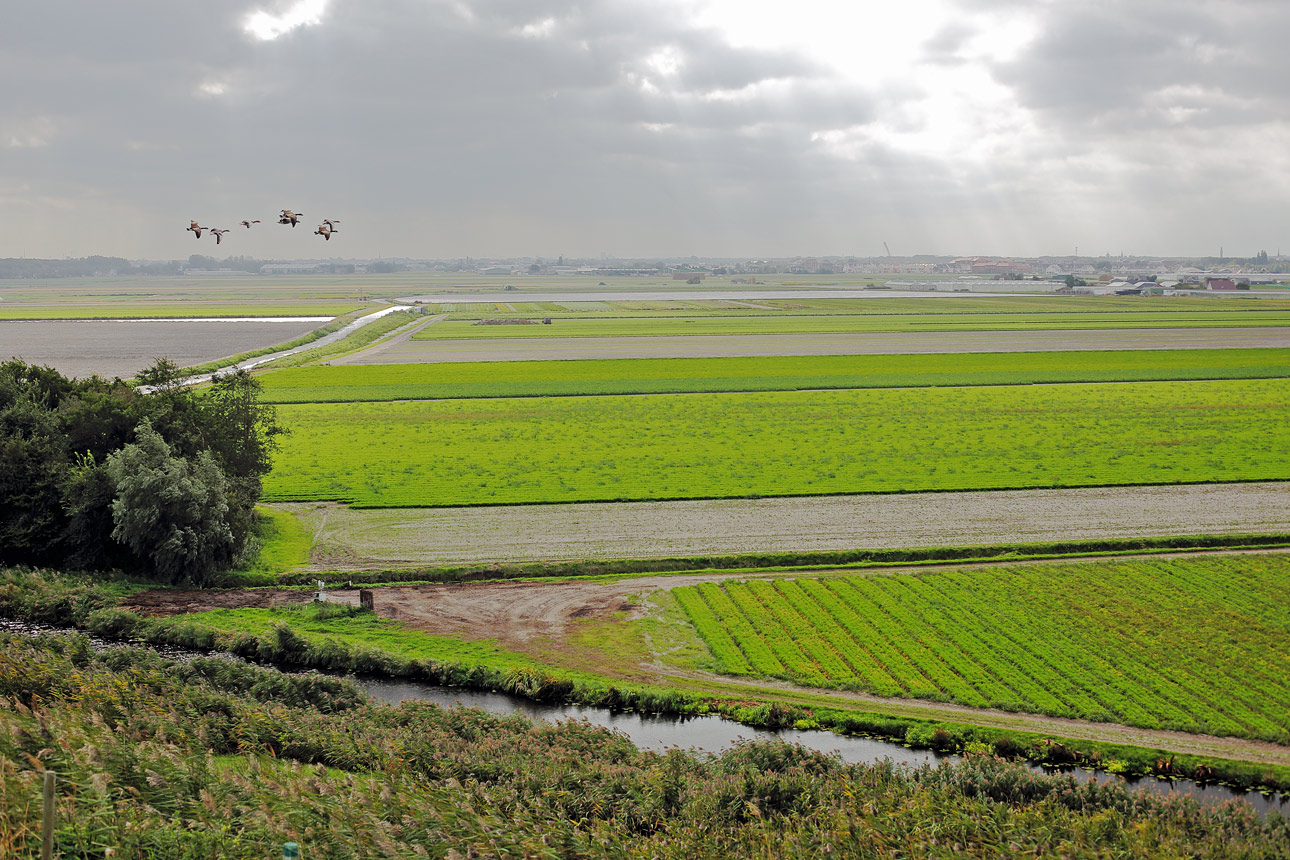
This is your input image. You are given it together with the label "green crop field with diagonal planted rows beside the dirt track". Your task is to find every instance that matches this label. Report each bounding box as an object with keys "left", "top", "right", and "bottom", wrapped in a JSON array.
[{"left": 672, "top": 554, "right": 1290, "bottom": 744}]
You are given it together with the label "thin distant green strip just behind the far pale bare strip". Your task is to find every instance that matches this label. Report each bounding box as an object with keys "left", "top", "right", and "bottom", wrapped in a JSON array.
[{"left": 413, "top": 304, "right": 1290, "bottom": 340}]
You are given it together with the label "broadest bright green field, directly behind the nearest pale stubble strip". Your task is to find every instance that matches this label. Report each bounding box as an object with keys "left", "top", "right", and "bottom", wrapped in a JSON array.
[{"left": 264, "top": 379, "right": 1290, "bottom": 507}]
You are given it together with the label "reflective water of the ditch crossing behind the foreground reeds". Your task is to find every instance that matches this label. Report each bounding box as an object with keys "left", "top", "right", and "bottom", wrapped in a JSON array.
[{"left": 0, "top": 619, "right": 1290, "bottom": 815}]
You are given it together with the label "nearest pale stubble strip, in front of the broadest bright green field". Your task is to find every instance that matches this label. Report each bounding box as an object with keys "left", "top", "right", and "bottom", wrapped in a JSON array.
[{"left": 275, "top": 482, "right": 1290, "bottom": 570}]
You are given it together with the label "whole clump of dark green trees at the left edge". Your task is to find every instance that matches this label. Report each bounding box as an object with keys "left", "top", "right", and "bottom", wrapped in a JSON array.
[{"left": 0, "top": 358, "right": 283, "bottom": 584}]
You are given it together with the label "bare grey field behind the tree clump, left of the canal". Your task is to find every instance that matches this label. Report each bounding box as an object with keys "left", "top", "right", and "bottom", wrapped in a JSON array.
[{"left": 0, "top": 320, "right": 325, "bottom": 379}]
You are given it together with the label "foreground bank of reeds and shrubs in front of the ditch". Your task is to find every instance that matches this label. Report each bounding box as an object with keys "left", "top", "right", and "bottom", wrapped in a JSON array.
[{"left": 0, "top": 637, "right": 1290, "bottom": 860}]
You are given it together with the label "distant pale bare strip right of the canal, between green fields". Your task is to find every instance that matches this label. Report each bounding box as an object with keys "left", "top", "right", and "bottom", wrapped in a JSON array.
[{"left": 332, "top": 327, "right": 1290, "bottom": 365}]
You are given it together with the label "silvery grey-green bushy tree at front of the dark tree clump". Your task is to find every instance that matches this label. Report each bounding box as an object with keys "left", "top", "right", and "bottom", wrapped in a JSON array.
[{"left": 106, "top": 422, "right": 235, "bottom": 585}]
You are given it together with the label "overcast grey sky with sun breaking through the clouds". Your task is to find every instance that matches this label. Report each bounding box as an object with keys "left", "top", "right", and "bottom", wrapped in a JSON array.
[{"left": 0, "top": 0, "right": 1290, "bottom": 259}]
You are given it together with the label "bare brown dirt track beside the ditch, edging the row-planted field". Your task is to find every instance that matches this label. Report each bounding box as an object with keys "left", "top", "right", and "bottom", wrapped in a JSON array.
[{"left": 128, "top": 569, "right": 1290, "bottom": 765}]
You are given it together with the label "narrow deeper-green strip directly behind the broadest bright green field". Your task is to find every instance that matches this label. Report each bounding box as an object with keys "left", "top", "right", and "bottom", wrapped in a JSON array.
[{"left": 261, "top": 349, "right": 1290, "bottom": 404}]
